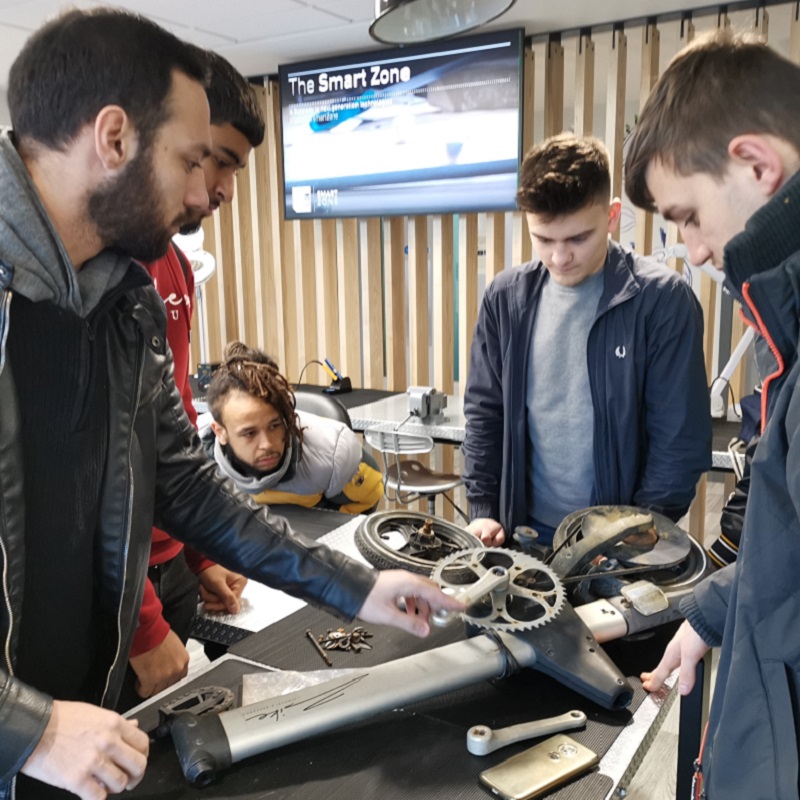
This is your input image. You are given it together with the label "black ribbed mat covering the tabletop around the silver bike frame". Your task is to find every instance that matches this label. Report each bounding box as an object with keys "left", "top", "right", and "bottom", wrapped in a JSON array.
[{"left": 130, "top": 608, "right": 672, "bottom": 800}]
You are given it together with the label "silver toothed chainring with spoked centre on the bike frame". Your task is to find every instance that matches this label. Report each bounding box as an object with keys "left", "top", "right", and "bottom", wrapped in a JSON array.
[{"left": 431, "top": 547, "right": 566, "bottom": 633}]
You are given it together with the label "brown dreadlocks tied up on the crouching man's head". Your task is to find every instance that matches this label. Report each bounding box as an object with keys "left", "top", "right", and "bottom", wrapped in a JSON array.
[{"left": 206, "top": 342, "right": 303, "bottom": 458}]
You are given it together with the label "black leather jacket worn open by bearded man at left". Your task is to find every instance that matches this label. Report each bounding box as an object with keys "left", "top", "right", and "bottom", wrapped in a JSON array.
[{"left": 0, "top": 260, "right": 377, "bottom": 800}]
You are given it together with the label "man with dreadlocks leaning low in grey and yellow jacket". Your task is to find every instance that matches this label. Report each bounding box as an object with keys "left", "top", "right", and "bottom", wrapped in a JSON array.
[{"left": 201, "top": 342, "right": 383, "bottom": 514}]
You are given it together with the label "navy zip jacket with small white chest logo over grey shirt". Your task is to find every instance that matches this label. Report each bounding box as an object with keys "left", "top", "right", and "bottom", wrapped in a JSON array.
[{"left": 463, "top": 242, "right": 711, "bottom": 535}]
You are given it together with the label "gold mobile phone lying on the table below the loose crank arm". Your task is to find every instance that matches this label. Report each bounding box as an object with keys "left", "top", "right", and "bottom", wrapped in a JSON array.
[{"left": 480, "top": 734, "right": 600, "bottom": 800}]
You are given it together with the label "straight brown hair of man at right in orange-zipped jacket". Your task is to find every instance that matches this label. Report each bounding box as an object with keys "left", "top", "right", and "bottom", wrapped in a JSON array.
[{"left": 625, "top": 29, "right": 800, "bottom": 208}]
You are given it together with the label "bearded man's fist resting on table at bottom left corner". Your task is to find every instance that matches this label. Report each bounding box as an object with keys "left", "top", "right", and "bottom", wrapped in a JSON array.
[{"left": 21, "top": 700, "right": 150, "bottom": 800}]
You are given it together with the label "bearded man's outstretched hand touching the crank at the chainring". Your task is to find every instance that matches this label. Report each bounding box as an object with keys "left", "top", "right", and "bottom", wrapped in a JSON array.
[{"left": 358, "top": 569, "right": 464, "bottom": 636}]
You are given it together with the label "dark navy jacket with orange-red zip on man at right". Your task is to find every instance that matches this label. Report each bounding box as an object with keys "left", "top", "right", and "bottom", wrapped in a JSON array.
[{"left": 681, "top": 174, "right": 800, "bottom": 800}]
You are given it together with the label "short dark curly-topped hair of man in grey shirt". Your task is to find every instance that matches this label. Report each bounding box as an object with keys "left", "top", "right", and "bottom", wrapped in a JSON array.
[{"left": 517, "top": 133, "right": 611, "bottom": 217}]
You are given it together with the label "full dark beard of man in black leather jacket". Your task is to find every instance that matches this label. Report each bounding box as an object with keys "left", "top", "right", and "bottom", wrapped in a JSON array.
[{"left": 88, "top": 141, "right": 193, "bottom": 261}]
